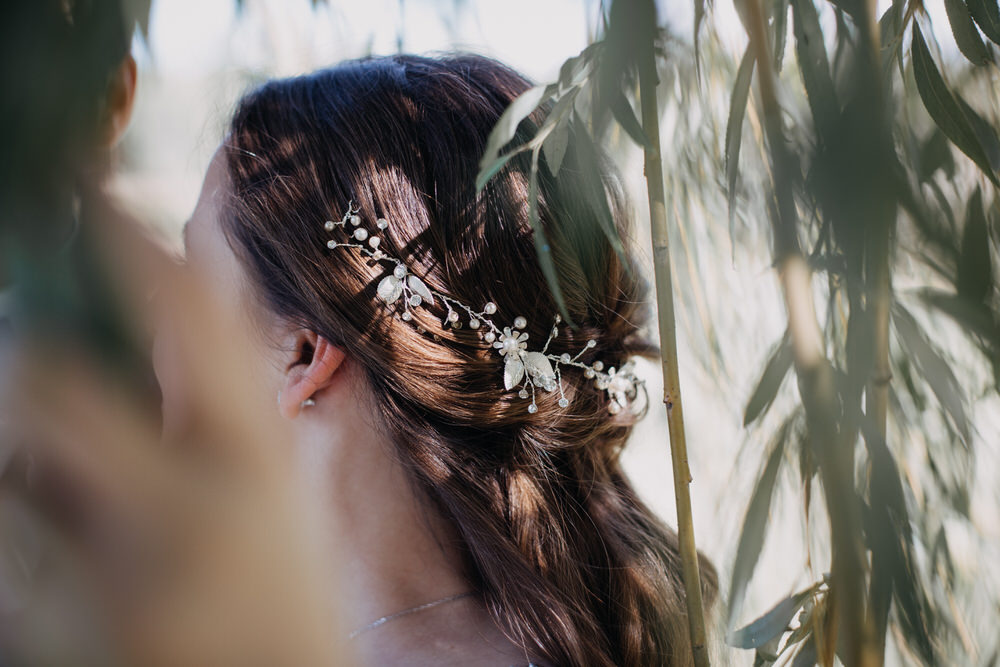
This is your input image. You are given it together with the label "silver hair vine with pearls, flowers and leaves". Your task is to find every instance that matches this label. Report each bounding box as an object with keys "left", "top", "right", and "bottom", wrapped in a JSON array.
[{"left": 323, "top": 201, "right": 646, "bottom": 414}]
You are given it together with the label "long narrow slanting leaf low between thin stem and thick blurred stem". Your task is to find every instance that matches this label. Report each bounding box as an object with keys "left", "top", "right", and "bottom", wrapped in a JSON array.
[{"left": 726, "top": 418, "right": 792, "bottom": 627}]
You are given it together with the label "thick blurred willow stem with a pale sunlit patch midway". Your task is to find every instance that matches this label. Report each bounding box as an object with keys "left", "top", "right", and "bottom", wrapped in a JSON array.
[{"left": 746, "top": 0, "right": 875, "bottom": 666}]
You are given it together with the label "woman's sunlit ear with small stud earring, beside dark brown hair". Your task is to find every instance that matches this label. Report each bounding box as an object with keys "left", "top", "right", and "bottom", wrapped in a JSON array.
[{"left": 278, "top": 330, "right": 347, "bottom": 419}]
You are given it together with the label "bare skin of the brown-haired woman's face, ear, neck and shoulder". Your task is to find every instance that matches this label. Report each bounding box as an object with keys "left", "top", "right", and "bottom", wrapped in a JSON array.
[{"left": 154, "top": 151, "right": 541, "bottom": 667}]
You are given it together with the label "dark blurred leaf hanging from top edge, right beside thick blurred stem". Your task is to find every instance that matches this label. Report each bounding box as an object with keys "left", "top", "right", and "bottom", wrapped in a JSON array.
[{"left": 792, "top": 0, "right": 840, "bottom": 140}]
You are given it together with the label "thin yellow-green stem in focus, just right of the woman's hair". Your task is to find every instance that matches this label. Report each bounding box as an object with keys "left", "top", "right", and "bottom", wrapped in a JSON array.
[{"left": 639, "top": 22, "right": 709, "bottom": 667}]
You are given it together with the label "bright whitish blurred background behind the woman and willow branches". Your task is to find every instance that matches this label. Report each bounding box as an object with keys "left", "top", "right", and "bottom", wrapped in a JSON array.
[{"left": 1, "top": 0, "right": 1000, "bottom": 665}]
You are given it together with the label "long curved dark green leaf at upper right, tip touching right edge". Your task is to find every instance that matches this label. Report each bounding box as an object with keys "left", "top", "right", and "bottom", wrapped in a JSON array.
[{"left": 911, "top": 23, "right": 1000, "bottom": 187}]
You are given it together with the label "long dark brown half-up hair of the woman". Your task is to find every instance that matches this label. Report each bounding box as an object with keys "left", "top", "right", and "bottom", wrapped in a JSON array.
[{"left": 224, "top": 49, "right": 716, "bottom": 665}]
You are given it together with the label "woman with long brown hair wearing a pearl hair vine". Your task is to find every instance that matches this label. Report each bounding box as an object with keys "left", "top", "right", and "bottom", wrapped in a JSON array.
[{"left": 157, "top": 49, "right": 716, "bottom": 667}]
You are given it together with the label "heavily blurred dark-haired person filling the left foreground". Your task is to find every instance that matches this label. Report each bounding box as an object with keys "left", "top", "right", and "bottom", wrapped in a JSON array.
[{"left": 0, "top": 0, "right": 354, "bottom": 667}]
